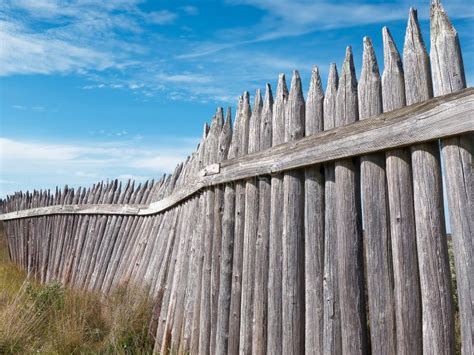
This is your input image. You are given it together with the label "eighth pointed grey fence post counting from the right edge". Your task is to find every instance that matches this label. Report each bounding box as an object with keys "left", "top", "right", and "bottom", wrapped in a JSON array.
[{"left": 282, "top": 71, "right": 305, "bottom": 354}]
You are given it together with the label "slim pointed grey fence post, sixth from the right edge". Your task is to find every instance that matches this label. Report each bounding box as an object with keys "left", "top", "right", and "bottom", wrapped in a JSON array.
[{"left": 322, "top": 63, "right": 342, "bottom": 355}]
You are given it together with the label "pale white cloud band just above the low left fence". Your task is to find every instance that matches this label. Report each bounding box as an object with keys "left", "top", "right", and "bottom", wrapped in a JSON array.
[{"left": 0, "top": 137, "right": 199, "bottom": 197}]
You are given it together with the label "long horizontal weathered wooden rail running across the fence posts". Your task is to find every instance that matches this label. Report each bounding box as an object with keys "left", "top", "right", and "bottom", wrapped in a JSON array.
[{"left": 0, "top": 88, "right": 474, "bottom": 220}]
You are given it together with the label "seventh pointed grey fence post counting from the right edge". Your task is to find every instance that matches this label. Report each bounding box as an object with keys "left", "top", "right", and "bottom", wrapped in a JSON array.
[{"left": 304, "top": 66, "right": 324, "bottom": 354}]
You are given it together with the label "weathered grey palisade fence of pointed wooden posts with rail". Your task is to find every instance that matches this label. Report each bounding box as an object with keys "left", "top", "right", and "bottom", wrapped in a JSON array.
[{"left": 0, "top": 1, "right": 474, "bottom": 355}]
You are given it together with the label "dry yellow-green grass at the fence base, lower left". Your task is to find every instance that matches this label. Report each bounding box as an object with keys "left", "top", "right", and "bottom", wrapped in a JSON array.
[{"left": 0, "top": 224, "right": 153, "bottom": 354}]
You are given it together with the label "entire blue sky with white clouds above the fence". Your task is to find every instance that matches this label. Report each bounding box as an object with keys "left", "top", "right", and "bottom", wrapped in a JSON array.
[{"left": 0, "top": 0, "right": 474, "bottom": 197}]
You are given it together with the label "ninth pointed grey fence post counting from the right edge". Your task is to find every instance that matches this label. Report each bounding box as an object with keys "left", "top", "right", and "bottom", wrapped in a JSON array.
[{"left": 267, "top": 74, "right": 288, "bottom": 355}]
